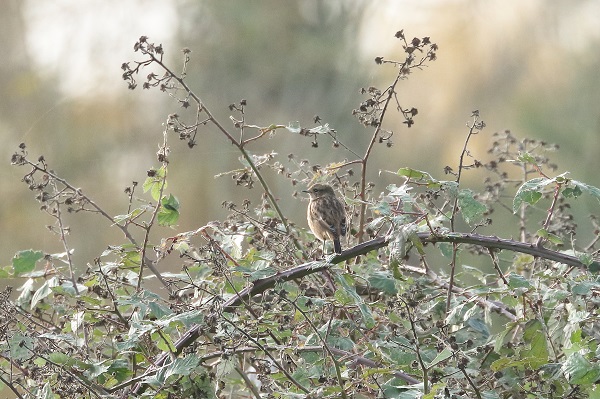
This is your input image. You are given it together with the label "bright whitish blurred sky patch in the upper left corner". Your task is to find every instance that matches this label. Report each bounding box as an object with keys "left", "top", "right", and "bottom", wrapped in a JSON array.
[{"left": 24, "top": 0, "right": 177, "bottom": 95}]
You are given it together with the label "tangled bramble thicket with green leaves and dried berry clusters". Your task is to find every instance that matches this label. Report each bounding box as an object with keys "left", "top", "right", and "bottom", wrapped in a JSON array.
[{"left": 0, "top": 31, "right": 600, "bottom": 398}]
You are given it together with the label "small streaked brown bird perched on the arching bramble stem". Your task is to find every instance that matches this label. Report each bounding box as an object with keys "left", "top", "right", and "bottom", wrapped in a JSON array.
[{"left": 304, "top": 183, "right": 346, "bottom": 254}]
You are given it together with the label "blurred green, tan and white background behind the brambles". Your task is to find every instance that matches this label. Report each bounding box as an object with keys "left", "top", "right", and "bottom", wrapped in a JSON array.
[{"left": 0, "top": 0, "right": 600, "bottom": 268}]
